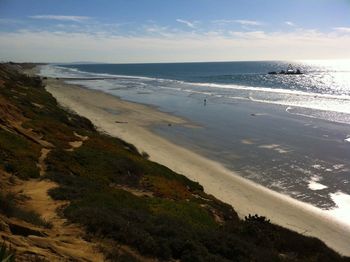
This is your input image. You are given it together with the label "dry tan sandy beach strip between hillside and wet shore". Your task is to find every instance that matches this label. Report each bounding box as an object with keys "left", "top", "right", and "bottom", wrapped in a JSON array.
[{"left": 46, "top": 79, "right": 350, "bottom": 256}]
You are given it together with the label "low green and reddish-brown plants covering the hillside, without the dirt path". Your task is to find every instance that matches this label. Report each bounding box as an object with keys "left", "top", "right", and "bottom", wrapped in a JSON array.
[{"left": 0, "top": 62, "right": 349, "bottom": 261}]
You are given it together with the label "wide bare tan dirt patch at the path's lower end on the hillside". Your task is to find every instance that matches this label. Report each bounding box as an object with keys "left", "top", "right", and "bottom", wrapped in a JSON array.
[{"left": 17, "top": 180, "right": 103, "bottom": 261}]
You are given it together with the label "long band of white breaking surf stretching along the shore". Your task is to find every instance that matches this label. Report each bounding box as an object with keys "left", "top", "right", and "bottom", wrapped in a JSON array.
[{"left": 41, "top": 65, "right": 350, "bottom": 121}]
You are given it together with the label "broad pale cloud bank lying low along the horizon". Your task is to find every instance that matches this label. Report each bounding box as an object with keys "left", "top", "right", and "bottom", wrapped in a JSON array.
[{"left": 0, "top": 28, "right": 350, "bottom": 63}]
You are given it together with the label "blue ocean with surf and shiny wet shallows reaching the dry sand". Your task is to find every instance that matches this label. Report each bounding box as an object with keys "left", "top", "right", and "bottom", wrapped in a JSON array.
[{"left": 41, "top": 60, "right": 350, "bottom": 224}]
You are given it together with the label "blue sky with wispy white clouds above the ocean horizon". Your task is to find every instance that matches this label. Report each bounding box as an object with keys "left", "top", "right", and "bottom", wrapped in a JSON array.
[{"left": 0, "top": 0, "right": 350, "bottom": 63}]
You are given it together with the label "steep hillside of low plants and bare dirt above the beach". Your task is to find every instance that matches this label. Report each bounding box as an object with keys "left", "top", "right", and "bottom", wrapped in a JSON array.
[{"left": 0, "top": 64, "right": 350, "bottom": 261}]
